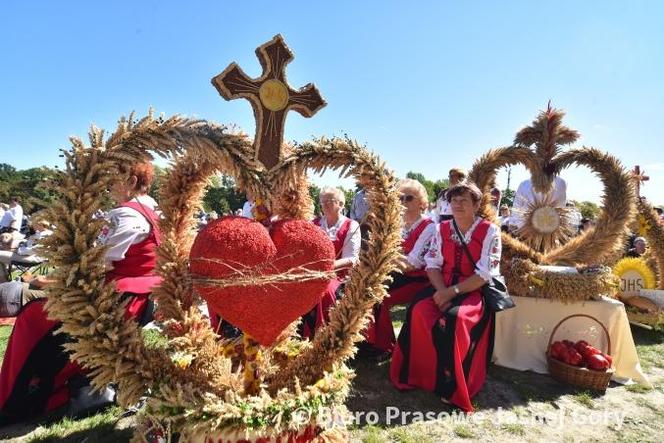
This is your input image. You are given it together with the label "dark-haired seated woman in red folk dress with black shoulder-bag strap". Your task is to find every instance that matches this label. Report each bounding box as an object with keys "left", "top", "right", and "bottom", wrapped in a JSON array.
[{"left": 390, "top": 182, "right": 501, "bottom": 412}]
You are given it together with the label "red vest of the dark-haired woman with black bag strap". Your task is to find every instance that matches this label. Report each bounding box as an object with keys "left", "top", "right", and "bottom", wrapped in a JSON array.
[{"left": 439, "top": 220, "right": 491, "bottom": 286}]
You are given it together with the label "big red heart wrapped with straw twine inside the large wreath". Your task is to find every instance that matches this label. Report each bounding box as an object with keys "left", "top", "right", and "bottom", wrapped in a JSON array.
[{"left": 190, "top": 217, "right": 334, "bottom": 346}]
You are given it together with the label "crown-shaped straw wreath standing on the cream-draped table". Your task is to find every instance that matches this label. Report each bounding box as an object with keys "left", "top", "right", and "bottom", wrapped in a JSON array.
[{"left": 469, "top": 104, "right": 635, "bottom": 301}]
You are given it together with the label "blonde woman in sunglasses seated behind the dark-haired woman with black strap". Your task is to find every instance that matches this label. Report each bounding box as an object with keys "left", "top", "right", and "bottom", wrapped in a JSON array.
[{"left": 365, "top": 179, "right": 436, "bottom": 352}]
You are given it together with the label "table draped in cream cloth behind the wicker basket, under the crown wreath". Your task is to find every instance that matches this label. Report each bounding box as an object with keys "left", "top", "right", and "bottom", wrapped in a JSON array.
[{"left": 493, "top": 296, "right": 652, "bottom": 387}]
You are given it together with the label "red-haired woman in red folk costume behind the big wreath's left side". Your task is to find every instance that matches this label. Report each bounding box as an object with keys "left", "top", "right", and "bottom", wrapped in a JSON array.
[{"left": 0, "top": 163, "right": 161, "bottom": 423}]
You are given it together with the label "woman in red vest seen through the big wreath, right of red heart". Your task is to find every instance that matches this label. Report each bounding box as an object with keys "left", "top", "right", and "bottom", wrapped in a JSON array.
[{"left": 302, "top": 187, "right": 362, "bottom": 338}]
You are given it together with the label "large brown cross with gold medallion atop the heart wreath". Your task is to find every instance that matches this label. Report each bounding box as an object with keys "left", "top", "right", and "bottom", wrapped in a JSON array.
[{"left": 212, "top": 35, "right": 327, "bottom": 169}]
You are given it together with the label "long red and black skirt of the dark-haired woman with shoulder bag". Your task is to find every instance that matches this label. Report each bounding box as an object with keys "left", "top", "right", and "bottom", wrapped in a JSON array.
[{"left": 390, "top": 288, "right": 494, "bottom": 412}]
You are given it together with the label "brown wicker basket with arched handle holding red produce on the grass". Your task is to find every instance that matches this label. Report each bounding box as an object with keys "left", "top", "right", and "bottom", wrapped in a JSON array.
[{"left": 546, "top": 314, "right": 615, "bottom": 392}]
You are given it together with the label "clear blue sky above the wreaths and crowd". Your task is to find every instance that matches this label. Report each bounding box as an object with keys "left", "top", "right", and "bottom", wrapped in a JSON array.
[{"left": 0, "top": 0, "right": 664, "bottom": 204}]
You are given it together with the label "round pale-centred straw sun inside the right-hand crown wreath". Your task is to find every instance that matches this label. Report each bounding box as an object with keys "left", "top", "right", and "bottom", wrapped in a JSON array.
[{"left": 517, "top": 195, "right": 574, "bottom": 252}]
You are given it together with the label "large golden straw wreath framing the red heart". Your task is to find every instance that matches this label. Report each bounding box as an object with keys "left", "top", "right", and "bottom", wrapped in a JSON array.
[{"left": 46, "top": 36, "right": 401, "bottom": 441}]
